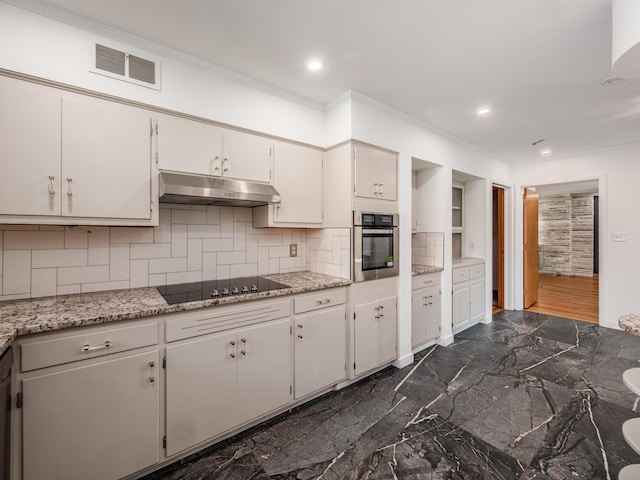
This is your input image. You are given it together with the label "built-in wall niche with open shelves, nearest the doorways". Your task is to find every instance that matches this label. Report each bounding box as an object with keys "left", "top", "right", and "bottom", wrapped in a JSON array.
[{"left": 448, "top": 170, "right": 488, "bottom": 258}]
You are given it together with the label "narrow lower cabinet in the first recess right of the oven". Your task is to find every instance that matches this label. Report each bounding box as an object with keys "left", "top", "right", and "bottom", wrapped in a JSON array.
[{"left": 411, "top": 274, "right": 441, "bottom": 348}]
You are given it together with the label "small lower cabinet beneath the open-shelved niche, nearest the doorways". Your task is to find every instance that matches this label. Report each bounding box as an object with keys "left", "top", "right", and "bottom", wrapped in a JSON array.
[{"left": 451, "top": 262, "right": 485, "bottom": 331}]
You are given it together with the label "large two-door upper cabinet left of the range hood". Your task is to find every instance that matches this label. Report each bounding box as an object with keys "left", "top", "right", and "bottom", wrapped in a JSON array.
[{"left": 0, "top": 78, "right": 157, "bottom": 225}]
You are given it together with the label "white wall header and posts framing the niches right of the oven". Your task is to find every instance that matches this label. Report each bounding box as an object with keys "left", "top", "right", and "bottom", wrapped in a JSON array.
[{"left": 351, "top": 92, "right": 512, "bottom": 366}]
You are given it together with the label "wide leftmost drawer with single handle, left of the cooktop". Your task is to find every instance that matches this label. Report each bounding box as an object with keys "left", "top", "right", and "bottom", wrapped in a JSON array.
[{"left": 20, "top": 322, "right": 158, "bottom": 372}]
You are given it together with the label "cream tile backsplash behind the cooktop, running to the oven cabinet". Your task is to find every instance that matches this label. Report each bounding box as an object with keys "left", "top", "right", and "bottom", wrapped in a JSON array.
[{"left": 0, "top": 205, "right": 350, "bottom": 300}]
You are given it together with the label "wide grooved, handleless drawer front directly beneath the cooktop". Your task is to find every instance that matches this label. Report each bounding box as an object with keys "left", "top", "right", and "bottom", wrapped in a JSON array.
[{"left": 166, "top": 300, "right": 291, "bottom": 342}]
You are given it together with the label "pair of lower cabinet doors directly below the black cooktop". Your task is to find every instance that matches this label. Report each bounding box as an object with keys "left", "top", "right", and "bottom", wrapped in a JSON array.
[{"left": 166, "top": 317, "right": 292, "bottom": 456}]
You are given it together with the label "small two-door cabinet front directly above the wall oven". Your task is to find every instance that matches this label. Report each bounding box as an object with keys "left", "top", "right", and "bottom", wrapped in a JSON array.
[{"left": 354, "top": 145, "right": 397, "bottom": 200}]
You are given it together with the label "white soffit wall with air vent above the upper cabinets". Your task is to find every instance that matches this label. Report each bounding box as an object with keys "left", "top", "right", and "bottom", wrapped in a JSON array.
[{"left": 0, "top": 2, "right": 324, "bottom": 146}]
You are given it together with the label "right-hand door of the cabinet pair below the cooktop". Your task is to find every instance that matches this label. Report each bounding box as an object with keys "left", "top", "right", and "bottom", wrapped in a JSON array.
[{"left": 237, "top": 318, "right": 292, "bottom": 424}]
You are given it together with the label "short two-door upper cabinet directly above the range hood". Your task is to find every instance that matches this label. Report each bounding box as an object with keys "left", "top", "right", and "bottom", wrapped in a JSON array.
[{"left": 158, "top": 115, "right": 273, "bottom": 183}]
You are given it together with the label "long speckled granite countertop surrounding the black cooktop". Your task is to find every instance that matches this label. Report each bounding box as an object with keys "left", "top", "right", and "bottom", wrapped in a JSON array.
[{"left": 0, "top": 272, "right": 351, "bottom": 355}]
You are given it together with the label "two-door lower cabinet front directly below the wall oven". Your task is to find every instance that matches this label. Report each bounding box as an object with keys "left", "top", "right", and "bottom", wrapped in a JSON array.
[{"left": 354, "top": 296, "right": 397, "bottom": 375}]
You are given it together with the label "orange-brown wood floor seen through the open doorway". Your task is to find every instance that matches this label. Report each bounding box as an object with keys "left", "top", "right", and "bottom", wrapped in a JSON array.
[{"left": 527, "top": 274, "right": 599, "bottom": 323}]
